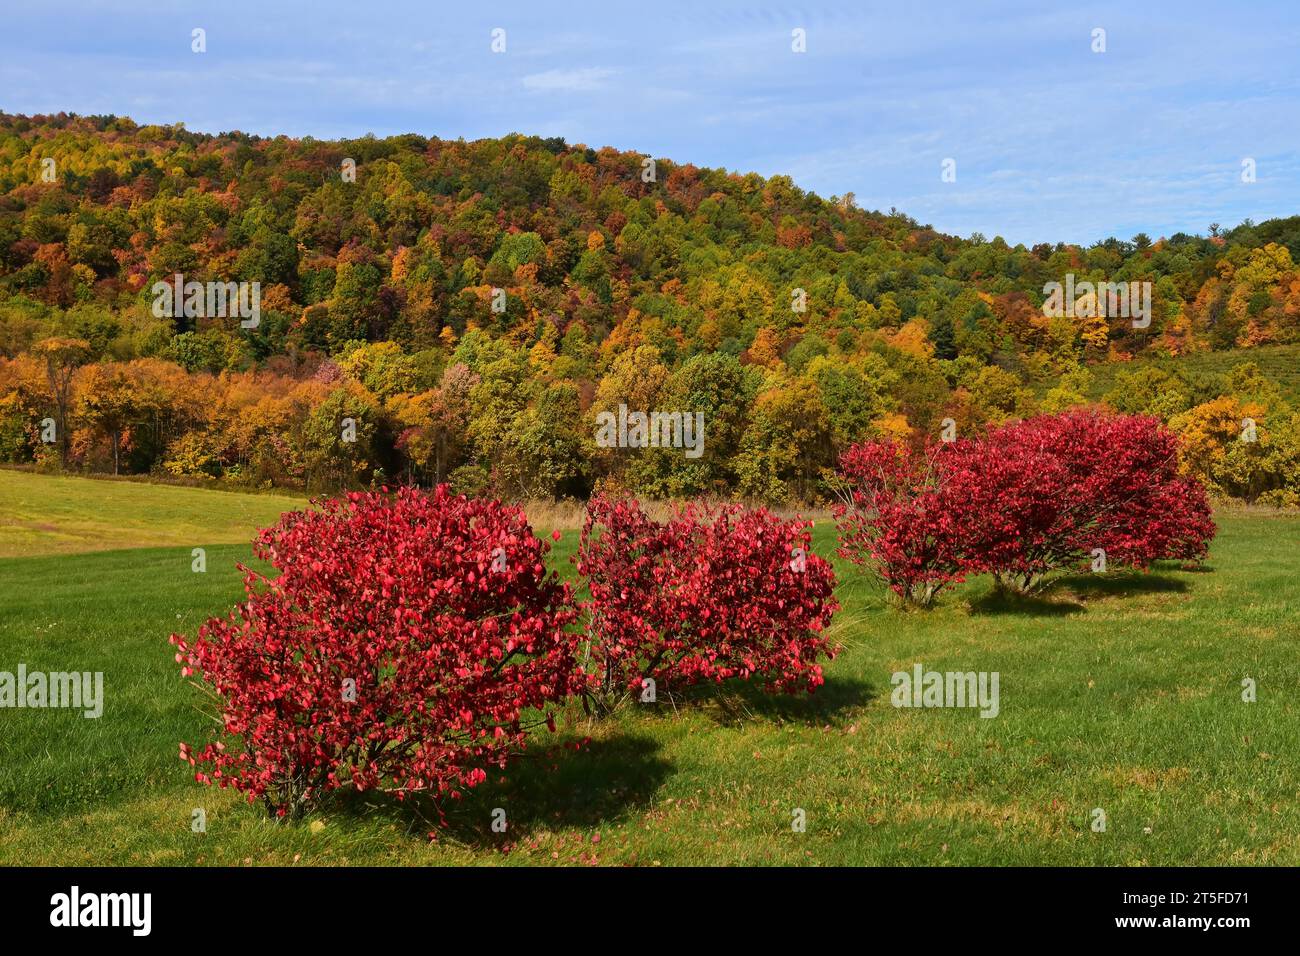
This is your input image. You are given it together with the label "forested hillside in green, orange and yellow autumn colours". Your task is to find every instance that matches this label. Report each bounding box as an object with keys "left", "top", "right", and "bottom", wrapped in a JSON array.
[{"left": 0, "top": 114, "right": 1300, "bottom": 503}]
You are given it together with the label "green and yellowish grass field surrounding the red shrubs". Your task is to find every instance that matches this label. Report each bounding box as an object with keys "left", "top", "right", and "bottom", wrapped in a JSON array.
[{"left": 0, "top": 472, "right": 1300, "bottom": 865}]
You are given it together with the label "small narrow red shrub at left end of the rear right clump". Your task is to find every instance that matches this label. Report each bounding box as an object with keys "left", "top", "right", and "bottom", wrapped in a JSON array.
[{"left": 835, "top": 441, "right": 962, "bottom": 606}]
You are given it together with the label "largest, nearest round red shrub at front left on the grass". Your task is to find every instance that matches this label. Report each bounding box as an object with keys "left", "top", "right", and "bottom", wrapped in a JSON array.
[{"left": 172, "top": 486, "right": 585, "bottom": 816}]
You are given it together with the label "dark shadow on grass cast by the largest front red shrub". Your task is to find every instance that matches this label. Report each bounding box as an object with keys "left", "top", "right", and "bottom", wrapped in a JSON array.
[{"left": 332, "top": 735, "right": 673, "bottom": 849}]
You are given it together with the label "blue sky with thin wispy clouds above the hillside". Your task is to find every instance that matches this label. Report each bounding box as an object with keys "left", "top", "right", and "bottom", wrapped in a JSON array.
[{"left": 0, "top": 0, "right": 1300, "bottom": 243}]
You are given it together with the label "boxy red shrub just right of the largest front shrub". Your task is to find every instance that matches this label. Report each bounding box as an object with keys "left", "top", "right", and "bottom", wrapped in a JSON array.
[{"left": 577, "top": 498, "right": 839, "bottom": 692}]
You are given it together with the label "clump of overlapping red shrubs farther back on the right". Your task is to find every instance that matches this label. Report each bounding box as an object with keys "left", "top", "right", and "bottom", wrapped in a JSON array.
[{"left": 837, "top": 411, "right": 1214, "bottom": 605}]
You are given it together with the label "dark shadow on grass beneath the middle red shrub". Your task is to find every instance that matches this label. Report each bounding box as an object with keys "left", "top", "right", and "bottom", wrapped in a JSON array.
[{"left": 657, "top": 676, "right": 876, "bottom": 727}]
